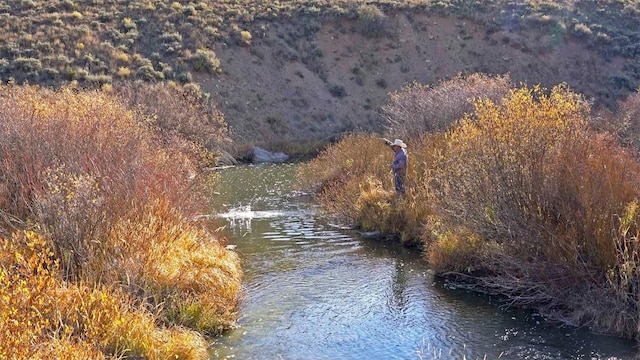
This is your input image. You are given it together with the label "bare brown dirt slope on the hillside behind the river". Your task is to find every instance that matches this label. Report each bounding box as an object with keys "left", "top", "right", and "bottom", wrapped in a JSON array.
[{"left": 198, "top": 12, "right": 629, "bottom": 148}]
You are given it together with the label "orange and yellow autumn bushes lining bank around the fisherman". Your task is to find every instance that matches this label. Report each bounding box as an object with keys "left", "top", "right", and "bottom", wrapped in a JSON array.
[{"left": 300, "top": 73, "right": 640, "bottom": 338}]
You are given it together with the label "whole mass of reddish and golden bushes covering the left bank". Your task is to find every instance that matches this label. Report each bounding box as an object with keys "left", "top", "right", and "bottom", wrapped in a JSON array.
[{"left": 0, "top": 86, "right": 241, "bottom": 358}]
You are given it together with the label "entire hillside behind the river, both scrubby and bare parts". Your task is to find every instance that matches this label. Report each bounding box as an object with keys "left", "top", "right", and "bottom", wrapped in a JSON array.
[{"left": 0, "top": 0, "right": 640, "bottom": 147}]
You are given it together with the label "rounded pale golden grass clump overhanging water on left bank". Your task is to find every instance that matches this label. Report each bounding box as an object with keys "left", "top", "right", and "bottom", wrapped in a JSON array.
[{"left": 105, "top": 198, "right": 242, "bottom": 334}]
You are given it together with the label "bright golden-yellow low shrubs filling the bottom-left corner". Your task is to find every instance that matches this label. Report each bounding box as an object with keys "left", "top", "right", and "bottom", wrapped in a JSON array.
[{"left": 0, "top": 231, "right": 208, "bottom": 359}]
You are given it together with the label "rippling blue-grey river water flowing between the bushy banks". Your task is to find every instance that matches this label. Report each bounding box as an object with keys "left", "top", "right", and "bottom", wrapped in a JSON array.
[{"left": 211, "top": 165, "right": 635, "bottom": 359}]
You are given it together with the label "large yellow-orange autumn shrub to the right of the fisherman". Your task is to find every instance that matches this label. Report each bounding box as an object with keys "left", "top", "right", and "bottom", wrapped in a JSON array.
[{"left": 429, "top": 87, "right": 640, "bottom": 337}]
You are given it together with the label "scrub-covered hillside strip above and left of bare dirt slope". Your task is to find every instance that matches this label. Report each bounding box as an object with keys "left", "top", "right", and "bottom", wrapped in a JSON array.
[{"left": 0, "top": 0, "right": 640, "bottom": 87}]
